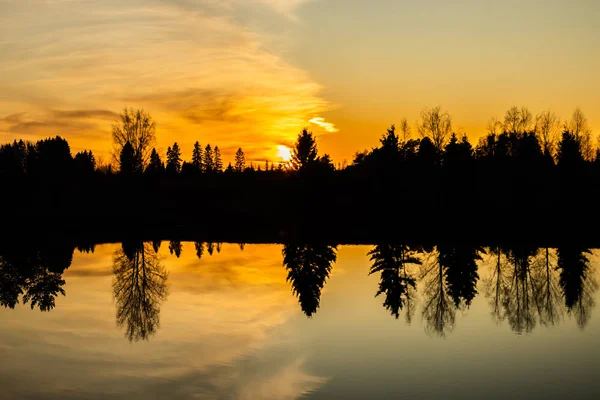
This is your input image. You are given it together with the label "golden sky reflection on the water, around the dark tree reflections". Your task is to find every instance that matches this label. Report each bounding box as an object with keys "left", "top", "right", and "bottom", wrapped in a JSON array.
[{"left": 0, "top": 242, "right": 600, "bottom": 399}]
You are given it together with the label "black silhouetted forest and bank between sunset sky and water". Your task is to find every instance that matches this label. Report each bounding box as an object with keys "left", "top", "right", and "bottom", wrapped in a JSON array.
[{"left": 0, "top": 107, "right": 600, "bottom": 243}]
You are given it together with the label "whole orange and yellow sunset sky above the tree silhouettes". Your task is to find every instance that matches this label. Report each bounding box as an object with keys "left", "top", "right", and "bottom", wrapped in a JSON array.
[{"left": 0, "top": 0, "right": 600, "bottom": 163}]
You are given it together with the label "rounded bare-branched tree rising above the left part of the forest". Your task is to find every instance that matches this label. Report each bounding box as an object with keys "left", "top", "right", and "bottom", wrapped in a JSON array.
[{"left": 112, "top": 107, "right": 156, "bottom": 168}]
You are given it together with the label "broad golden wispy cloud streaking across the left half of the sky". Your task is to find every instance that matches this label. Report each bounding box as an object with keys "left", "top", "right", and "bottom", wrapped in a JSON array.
[{"left": 0, "top": 0, "right": 334, "bottom": 160}]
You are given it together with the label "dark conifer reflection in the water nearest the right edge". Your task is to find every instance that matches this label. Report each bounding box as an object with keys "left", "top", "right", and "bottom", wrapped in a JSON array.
[{"left": 556, "top": 246, "right": 597, "bottom": 329}]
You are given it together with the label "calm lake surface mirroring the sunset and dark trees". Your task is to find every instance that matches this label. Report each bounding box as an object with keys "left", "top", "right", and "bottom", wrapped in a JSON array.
[{"left": 0, "top": 242, "right": 600, "bottom": 399}]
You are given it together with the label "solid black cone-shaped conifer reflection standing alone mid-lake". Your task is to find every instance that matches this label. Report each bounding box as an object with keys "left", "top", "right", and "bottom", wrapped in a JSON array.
[{"left": 282, "top": 244, "right": 337, "bottom": 317}]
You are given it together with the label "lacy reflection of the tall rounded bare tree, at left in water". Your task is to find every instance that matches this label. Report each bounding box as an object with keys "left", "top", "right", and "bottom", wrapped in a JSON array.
[{"left": 113, "top": 242, "right": 168, "bottom": 341}]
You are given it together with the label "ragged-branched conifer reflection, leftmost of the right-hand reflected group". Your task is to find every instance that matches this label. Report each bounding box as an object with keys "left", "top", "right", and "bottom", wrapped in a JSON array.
[{"left": 367, "top": 244, "right": 421, "bottom": 323}]
